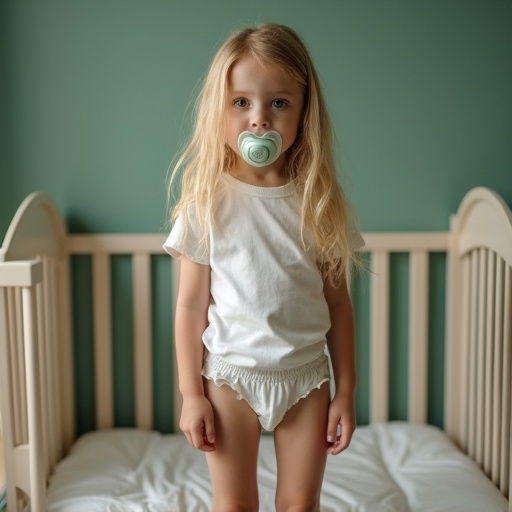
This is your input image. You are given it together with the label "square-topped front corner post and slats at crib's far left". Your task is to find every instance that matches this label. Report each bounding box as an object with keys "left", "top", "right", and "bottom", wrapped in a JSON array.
[{"left": 0, "top": 260, "right": 46, "bottom": 512}]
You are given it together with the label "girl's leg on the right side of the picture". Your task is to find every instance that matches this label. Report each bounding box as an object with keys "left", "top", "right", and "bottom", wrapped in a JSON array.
[{"left": 274, "top": 382, "right": 330, "bottom": 512}]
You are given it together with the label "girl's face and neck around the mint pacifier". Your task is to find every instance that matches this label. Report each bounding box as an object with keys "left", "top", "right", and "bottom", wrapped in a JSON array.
[{"left": 226, "top": 56, "right": 304, "bottom": 183}]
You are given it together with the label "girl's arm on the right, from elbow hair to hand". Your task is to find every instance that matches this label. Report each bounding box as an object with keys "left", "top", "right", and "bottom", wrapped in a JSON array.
[{"left": 324, "top": 281, "right": 356, "bottom": 455}]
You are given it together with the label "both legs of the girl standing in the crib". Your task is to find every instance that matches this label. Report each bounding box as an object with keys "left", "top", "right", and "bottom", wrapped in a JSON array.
[{"left": 205, "top": 380, "right": 330, "bottom": 512}]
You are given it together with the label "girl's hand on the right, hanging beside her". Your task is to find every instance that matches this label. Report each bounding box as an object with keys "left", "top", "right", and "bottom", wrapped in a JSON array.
[{"left": 327, "top": 394, "right": 356, "bottom": 455}]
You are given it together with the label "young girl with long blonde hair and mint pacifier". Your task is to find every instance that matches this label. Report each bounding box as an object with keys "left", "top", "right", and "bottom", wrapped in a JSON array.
[{"left": 164, "top": 24, "right": 362, "bottom": 512}]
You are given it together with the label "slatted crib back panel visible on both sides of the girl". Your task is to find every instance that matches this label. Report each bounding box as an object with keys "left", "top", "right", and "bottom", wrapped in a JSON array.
[{"left": 68, "top": 233, "right": 448, "bottom": 432}]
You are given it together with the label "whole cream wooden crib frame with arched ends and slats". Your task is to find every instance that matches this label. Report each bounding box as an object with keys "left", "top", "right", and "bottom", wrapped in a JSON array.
[{"left": 0, "top": 188, "right": 512, "bottom": 512}]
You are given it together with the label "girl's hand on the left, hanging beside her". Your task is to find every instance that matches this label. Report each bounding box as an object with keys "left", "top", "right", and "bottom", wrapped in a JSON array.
[{"left": 180, "top": 396, "right": 215, "bottom": 452}]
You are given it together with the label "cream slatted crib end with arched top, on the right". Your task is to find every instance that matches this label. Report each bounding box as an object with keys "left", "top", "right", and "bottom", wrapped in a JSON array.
[{"left": 446, "top": 188, "right": 512, "bottom": 496}]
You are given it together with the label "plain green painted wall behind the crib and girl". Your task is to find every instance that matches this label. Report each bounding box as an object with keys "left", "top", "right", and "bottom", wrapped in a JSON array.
[{"left": 0, "top": 0, "right": 512, "bottom": 430}]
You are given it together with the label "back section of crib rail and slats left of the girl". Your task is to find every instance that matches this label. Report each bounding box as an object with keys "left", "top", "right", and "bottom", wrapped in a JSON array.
[{"left": 67, "top": 234, "right": 181, "bottom": 432}]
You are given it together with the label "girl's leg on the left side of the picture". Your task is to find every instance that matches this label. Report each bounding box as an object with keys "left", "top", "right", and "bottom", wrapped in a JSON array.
[{"left": 204, "top": 380, "right": 261, "bottom": 512}]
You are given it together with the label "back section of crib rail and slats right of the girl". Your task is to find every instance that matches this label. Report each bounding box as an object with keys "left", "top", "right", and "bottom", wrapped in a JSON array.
[{"left": 355, "top": 232, "right": 448, "bottom": 423}]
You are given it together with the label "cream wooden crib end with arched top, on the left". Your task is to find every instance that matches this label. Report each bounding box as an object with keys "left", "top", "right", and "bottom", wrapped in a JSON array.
[{"left": 0, "top": 193, "right": 74, "bottom": 512}]
